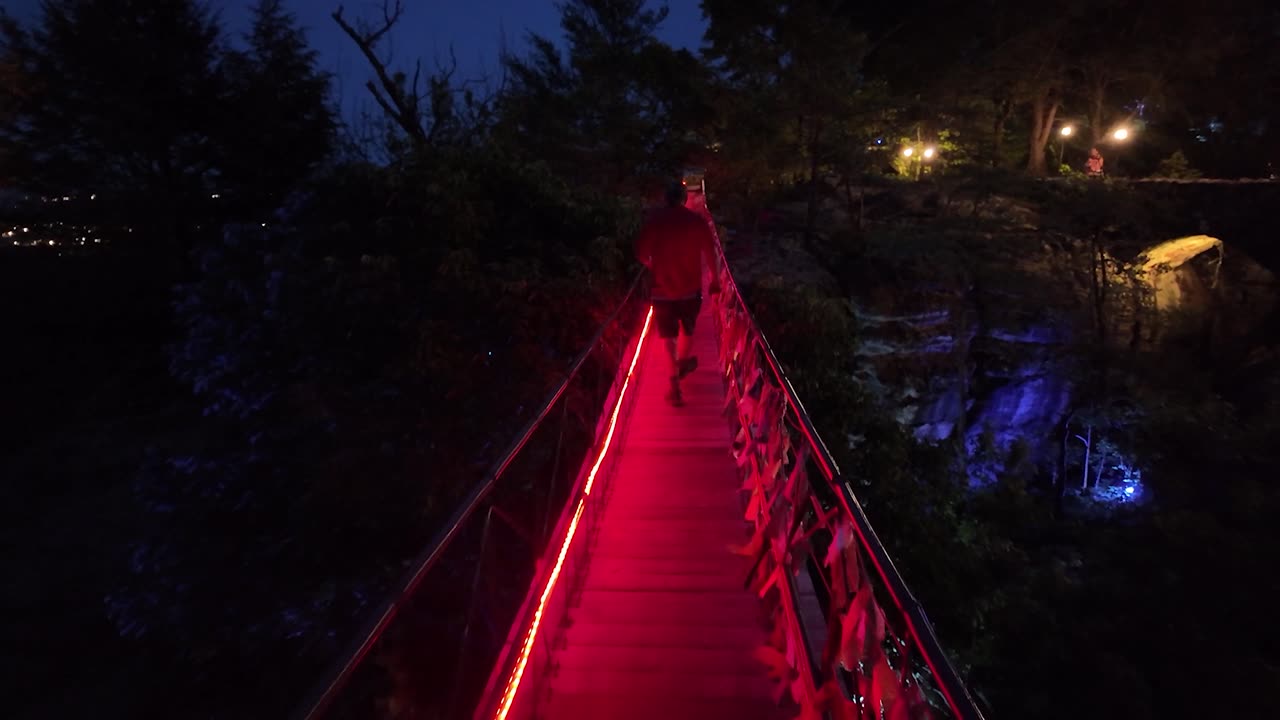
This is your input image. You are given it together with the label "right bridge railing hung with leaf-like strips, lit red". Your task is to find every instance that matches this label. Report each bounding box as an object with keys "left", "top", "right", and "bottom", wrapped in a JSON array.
[{"left": 708, "top": 215, "right": 982, "bottom": 720}]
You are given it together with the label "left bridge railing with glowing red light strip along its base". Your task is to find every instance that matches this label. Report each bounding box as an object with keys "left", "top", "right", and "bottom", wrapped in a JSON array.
[{"left": 296, "top": 270, "right": 649, "bottom": 720}]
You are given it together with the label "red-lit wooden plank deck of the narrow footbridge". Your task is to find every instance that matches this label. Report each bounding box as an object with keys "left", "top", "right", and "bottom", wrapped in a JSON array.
[{"left": 538, "top": 300, "right": 794, "bottom": 720}]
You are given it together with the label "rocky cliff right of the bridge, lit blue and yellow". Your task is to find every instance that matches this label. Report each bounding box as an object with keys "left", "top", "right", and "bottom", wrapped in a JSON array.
[{"left": 739, "top": 185, "right": 1277, "bottom": 492}]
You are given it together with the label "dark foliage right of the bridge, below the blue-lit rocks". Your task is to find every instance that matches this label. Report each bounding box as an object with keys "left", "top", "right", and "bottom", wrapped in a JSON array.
[{"left": 749, "top": 198, "right": 1280, "bottom": 719}]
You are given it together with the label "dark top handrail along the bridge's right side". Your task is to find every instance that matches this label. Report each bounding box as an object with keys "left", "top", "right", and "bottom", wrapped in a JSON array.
[{"left": 708, "top": 202, "right": 983, "bottom": 720}]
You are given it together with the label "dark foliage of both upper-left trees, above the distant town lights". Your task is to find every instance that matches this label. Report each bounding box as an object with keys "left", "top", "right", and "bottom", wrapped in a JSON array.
[{"left": 0, "top": 0, "right": 334, "bottom": 233}]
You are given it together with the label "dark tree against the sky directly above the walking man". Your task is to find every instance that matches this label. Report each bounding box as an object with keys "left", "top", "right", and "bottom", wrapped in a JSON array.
[{"left": 497, "top": 0, "right": 710, "bottom": 191}]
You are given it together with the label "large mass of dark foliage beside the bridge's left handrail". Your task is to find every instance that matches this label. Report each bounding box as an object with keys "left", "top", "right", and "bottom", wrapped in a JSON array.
[{"left": 103, "top": 144, "right": 634, "bottom": 710}]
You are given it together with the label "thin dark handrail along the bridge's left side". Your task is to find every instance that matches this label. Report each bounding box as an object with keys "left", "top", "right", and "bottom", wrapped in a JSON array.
[{"left": 298, "top": 270, "right": 644, "bottom": 720}]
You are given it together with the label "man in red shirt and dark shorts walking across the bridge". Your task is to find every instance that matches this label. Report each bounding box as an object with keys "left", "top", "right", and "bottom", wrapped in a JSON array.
[{"left": 636, "top": 182, "right": 719, "bottom": 406}]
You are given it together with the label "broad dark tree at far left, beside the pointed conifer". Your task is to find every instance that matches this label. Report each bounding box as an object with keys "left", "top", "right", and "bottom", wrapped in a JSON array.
[{"left": 0, "top": 0, "right": 223, "bottom": 202}]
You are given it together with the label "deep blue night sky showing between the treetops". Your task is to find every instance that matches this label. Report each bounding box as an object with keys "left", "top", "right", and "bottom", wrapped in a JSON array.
[{"left": 4, "top": 0, "right": 705, "bottom": 113}]
